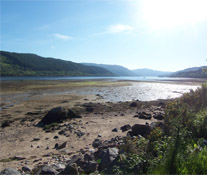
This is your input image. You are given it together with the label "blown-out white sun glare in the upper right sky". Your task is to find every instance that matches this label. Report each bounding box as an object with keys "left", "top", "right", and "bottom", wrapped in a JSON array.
[{"left": 139, "top": 0, "right": 207, "bottom": 29}]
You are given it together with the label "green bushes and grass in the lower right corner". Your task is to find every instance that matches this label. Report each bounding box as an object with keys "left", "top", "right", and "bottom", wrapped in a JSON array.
[{"left": 108, "top": 83, "right": 207, "bottom": 174}]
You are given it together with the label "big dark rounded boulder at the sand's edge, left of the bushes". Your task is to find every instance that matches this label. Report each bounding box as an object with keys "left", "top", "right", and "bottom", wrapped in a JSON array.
[{"left": 131, "top": 124, "right": 150, "bottom": 136}]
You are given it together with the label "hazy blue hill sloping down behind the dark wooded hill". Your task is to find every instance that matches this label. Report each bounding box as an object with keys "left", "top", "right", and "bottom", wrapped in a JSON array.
[{"left": 82, "top": 63, "right": 138, "bottom": 76}]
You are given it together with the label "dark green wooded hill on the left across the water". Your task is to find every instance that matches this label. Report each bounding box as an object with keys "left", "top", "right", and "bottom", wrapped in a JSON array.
[{"left": 0, "top": 51, "right": 114, "bottom": 76}]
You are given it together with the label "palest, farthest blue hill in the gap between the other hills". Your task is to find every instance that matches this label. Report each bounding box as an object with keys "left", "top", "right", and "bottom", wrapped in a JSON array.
[{"left": 133, "top": 69, "right": 172, "bottom": 76}]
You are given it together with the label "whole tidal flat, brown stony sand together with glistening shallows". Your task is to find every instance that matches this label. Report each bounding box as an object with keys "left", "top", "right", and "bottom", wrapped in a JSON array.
[{"left": 0, "top": 80, "right": 200, "bottom": 170}]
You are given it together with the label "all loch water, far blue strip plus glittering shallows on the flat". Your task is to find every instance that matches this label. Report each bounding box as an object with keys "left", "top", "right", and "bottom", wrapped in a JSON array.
[{"left": 0, "top": 77, "right": 199, "bottom": 110}]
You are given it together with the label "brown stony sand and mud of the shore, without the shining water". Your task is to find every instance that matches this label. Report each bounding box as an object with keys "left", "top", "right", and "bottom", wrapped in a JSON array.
[{"left": 0, "top": 81, "right": 204, "bottom": 170}]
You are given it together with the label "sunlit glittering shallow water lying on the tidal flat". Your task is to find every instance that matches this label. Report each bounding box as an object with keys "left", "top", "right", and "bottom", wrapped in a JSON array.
[{"left": 50, "top": 82, "right": 199, "bottom": 102}]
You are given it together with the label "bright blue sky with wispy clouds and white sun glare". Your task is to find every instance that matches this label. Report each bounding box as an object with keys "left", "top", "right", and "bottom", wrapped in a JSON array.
[{"left": 0, "top": 0, "right": 207, "bottom": 71}]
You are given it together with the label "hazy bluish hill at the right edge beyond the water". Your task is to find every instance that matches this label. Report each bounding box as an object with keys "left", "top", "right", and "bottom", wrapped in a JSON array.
[{"left": 168, "top": 66, "right": 207, "bottom": 78}]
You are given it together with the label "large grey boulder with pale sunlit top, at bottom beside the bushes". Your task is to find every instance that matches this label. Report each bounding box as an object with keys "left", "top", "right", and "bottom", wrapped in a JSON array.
[{"left": 99, "top": 147, "right": 119, "bottom": 170}]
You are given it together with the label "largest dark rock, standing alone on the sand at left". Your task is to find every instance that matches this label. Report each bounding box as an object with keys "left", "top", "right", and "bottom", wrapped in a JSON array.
[{"left": 38, "top": 107, "right": 81, "bottom": 126}]
